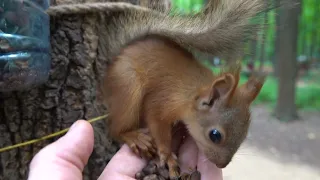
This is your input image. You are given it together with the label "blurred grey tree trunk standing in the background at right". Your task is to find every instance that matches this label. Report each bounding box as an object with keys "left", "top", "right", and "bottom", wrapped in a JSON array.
[{"left": 275, "top": 0, "right": 301, "bottom": 121}]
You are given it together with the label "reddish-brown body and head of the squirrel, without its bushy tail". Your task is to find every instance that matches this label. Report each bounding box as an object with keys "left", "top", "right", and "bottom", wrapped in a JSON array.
[{"left": 104, "top": 36, "right": 264, "bottom": 178}]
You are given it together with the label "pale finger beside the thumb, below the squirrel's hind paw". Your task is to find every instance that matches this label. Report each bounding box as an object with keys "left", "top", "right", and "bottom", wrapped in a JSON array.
[{"left": 99, "top": 144, "right": 146, "bottom": 180}]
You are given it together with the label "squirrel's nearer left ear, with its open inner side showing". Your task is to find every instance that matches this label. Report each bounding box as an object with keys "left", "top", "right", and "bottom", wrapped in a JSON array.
[{"left": 197, "top": 73, "right": 237, "bottom": 110}]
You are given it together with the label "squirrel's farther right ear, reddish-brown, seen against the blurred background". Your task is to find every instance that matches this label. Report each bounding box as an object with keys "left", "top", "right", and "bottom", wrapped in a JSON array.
[{"left": 239, "top": 73, "right": 266, "bottom": 104}]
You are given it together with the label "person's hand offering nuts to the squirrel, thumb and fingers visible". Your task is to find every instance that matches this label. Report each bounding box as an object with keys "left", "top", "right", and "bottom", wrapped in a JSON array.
[{"left": 28, "top": 120, "right": 222, "bottom": 180}]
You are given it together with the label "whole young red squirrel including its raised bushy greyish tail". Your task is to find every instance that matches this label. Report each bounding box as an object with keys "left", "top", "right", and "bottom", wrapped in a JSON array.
[{"left": 48, "top": 0, "right": 266, "bottom": 179}]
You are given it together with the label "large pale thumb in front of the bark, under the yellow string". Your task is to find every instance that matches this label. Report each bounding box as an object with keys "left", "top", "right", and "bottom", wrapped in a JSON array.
[{"left": 28, "top": 120, "right": 94, "bottom": 180}]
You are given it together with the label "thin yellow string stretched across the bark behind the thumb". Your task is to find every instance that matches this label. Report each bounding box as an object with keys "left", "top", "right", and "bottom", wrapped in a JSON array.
[{"left": 0, "top": 115, "right": 108, "bottom": 153}]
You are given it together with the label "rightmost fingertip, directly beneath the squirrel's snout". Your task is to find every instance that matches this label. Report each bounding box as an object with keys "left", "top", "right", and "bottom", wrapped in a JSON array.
[{"left": 198, "top": 151, "right": 223, "bottom": 180}]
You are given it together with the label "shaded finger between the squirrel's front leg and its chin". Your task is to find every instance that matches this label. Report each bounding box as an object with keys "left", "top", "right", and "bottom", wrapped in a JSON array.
[{"left": 178, "top": 136, "right": 198, "bottom": 173}]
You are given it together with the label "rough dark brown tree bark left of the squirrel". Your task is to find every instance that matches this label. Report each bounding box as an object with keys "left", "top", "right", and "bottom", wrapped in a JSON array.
[{"left": 0, "top": 0, "right": 169, "bottom": 180}]
